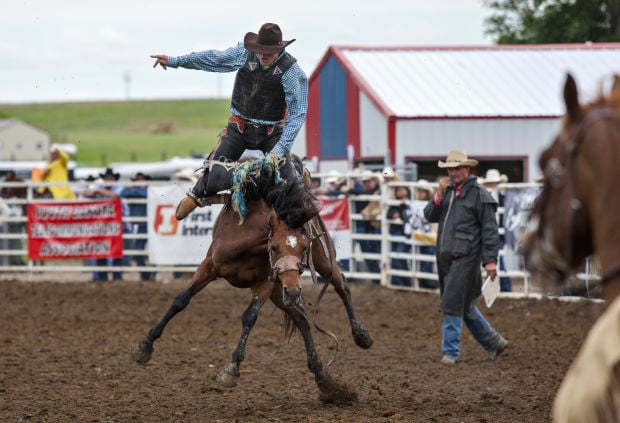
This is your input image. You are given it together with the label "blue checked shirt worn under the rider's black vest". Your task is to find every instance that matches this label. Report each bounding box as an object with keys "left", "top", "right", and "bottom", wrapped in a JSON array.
[{"left": 168, "top": 43, "right": 308, "bottom": 155}]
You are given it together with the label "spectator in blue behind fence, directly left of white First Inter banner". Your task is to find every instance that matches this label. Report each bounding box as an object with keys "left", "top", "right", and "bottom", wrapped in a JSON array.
[{"left": 121, "top": 172, "right": 155, "bottom": 281}]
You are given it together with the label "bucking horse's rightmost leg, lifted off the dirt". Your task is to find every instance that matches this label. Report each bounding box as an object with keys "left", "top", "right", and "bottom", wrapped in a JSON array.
[{"left": 312, "top": 233, "right": 373, "bottom": 348}]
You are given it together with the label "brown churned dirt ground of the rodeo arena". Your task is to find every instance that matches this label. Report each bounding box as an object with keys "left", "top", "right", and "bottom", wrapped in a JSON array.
[{"left": 0, "top": 280, "right": 602, "bottom": 423}]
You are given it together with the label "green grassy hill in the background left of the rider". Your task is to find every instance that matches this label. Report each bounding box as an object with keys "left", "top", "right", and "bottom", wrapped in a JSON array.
[{"left": 0, "top": 99, "right": 230, "bottom": 166}]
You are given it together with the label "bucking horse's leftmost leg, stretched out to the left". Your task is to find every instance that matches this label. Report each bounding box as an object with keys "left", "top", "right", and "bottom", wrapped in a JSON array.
[{"left": 133, "top": 257, "right": 216, "bottom": 364}]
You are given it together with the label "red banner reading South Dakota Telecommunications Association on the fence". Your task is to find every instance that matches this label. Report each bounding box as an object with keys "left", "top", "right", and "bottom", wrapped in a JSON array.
[{"left": 28, "top": 200, "right": 123, "bottom": 260}]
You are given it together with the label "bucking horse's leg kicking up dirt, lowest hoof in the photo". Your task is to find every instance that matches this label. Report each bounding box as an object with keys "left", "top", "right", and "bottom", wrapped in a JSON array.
[{"left": 271, "top": 289, "right": 357, "bottom": 405}]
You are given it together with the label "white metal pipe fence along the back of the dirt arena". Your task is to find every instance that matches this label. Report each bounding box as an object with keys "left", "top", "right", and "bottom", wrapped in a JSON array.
[{"left": 0, "top": 174, "right": 598, "bottom": 296}]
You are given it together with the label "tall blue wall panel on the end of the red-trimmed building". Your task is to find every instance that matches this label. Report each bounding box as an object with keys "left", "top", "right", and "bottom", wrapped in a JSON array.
[{"left": 320, "top": 56, "right": 347, "bottom": 158}]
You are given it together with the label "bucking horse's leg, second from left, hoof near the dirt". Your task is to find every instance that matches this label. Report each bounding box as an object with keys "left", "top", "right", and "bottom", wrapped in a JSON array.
[{"left": 216, "top": 281, "right": 273, "bottom": 388}]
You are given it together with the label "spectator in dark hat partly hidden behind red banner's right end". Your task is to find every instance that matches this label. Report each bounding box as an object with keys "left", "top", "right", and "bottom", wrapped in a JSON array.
[{"left": 82, "top": 168, "right": 131, "bottom": 282}]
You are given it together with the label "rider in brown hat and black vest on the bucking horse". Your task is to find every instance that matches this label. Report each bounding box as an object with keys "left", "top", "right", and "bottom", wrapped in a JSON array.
[{"left": 151, "top": 23, "right": 308, "bottom": 220}]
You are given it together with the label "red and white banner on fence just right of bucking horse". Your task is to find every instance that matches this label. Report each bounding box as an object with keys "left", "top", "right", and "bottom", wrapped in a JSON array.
[{"left": 318, "top": 197, "right": 351, "bottom": 260}]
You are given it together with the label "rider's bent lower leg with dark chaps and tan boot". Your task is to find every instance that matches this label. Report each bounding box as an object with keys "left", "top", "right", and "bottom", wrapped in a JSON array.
[{"left": 175, "top": 162, "right": 234, "bottom": 220}]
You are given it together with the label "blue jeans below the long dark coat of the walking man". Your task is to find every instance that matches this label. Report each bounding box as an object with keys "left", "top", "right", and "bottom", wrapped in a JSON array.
[{"left": 441, "top": 304, "right": 502, "bottom": 360}]
